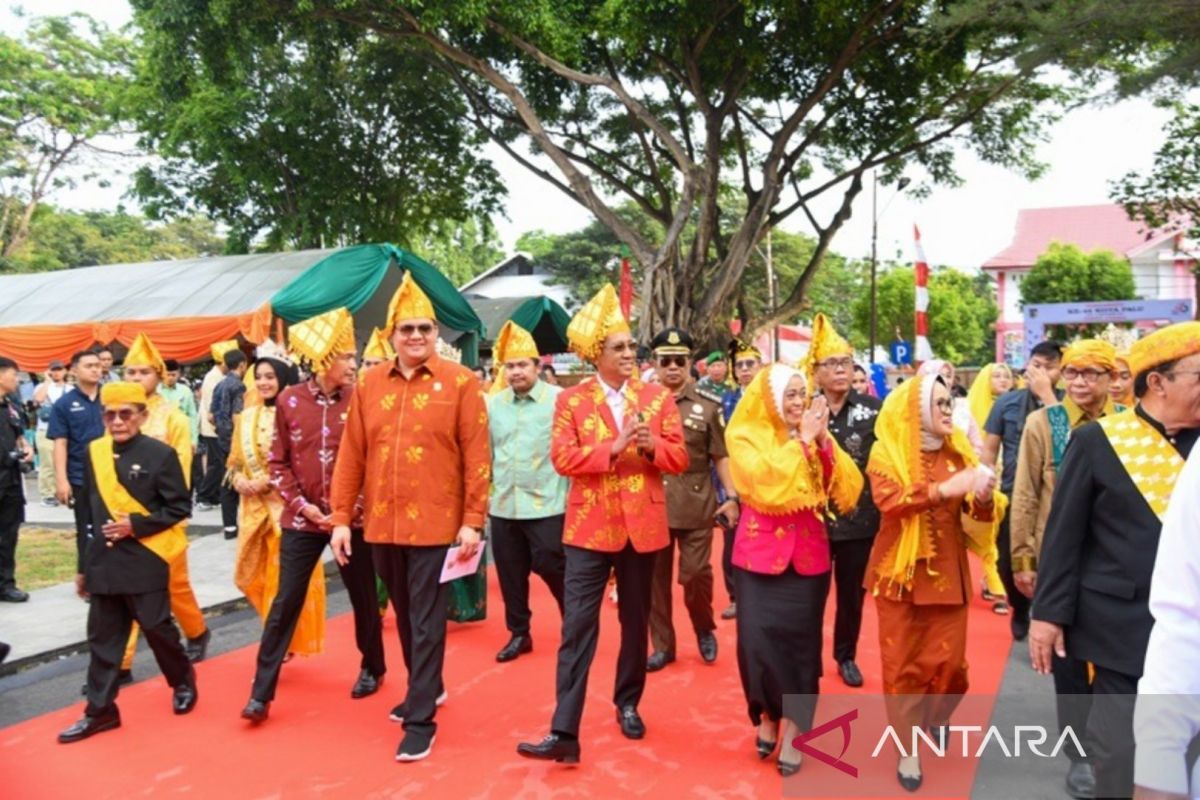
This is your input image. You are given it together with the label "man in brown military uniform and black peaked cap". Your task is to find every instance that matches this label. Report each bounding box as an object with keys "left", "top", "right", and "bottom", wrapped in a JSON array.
[{"left": 650, "top": 328, "right": 728, "bottom": 657}]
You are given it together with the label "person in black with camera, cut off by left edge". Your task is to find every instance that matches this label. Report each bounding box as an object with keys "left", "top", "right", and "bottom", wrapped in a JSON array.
[{"left": 0, "top": 356, "right": 34, "bottom": 603}]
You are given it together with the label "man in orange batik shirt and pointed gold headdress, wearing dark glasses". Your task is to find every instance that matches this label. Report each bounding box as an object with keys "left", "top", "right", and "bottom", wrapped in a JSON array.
[{"left": 332, "top": 272, "right": 492, "bottom": 762}]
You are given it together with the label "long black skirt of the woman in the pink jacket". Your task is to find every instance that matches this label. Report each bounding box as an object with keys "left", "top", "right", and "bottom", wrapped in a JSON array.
[{"left": 733, "top": 565, "right": 830, "bottom": 730}]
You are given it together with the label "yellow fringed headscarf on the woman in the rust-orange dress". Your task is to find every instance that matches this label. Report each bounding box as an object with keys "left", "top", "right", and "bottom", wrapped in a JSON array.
[{"left": 866, "top": 374, "right": 1008, "bottom": 594}]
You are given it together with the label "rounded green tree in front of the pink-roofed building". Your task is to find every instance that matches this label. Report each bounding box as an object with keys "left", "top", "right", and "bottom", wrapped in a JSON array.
[{"left": 1021, "top": 242, "right": 1138, "bottom": 342}]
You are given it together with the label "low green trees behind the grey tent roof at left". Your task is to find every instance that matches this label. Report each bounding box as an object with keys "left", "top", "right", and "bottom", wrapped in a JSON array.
[{"left": 7, "top": 205, "right": 224, "bottom": 272}]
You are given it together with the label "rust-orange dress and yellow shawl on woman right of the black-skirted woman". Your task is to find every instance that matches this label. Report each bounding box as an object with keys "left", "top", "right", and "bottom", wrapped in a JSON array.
[{"left": 864, "top": 375, "right": 1006, "bottom": 741}]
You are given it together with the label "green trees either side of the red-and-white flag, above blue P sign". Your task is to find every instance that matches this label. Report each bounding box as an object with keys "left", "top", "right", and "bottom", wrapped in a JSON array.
[{"left": 852, "top": 267, "right": 1000, "bottom": 366}]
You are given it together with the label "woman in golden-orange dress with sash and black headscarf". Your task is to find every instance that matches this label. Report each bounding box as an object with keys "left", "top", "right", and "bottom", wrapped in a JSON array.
[{"left": 228, "top": 356, "right": 325, "bottom": 656}]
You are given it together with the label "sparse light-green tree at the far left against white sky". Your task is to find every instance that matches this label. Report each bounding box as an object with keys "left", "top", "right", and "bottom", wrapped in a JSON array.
[{"left": 0, "top": 14, "right": 131, "bottom": 262}]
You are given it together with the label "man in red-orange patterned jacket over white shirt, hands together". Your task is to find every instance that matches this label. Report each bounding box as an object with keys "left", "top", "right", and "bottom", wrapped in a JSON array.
[{"left": 517, "top": 284, "right": 688, "bottom": 764}]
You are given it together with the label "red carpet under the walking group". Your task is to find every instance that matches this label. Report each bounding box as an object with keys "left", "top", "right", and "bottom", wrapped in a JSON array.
[{"left": 0, "top": 551, "right": 1010, "bottom": 800}]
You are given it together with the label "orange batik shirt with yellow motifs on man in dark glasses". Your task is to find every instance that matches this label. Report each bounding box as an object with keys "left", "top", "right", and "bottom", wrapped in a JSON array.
[{"left": 330, "top": 355, "right": 492, "bottom": 546}]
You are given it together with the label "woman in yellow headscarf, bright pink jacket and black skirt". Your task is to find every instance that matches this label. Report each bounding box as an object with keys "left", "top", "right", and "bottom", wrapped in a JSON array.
[{"left": 725, "top": 363, "right": 863, "bottom": 777}]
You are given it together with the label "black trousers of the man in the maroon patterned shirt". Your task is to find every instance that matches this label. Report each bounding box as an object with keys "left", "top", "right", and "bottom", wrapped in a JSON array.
[{"left": 251, "top": 528, "right": 388, "bottom": 703}]
